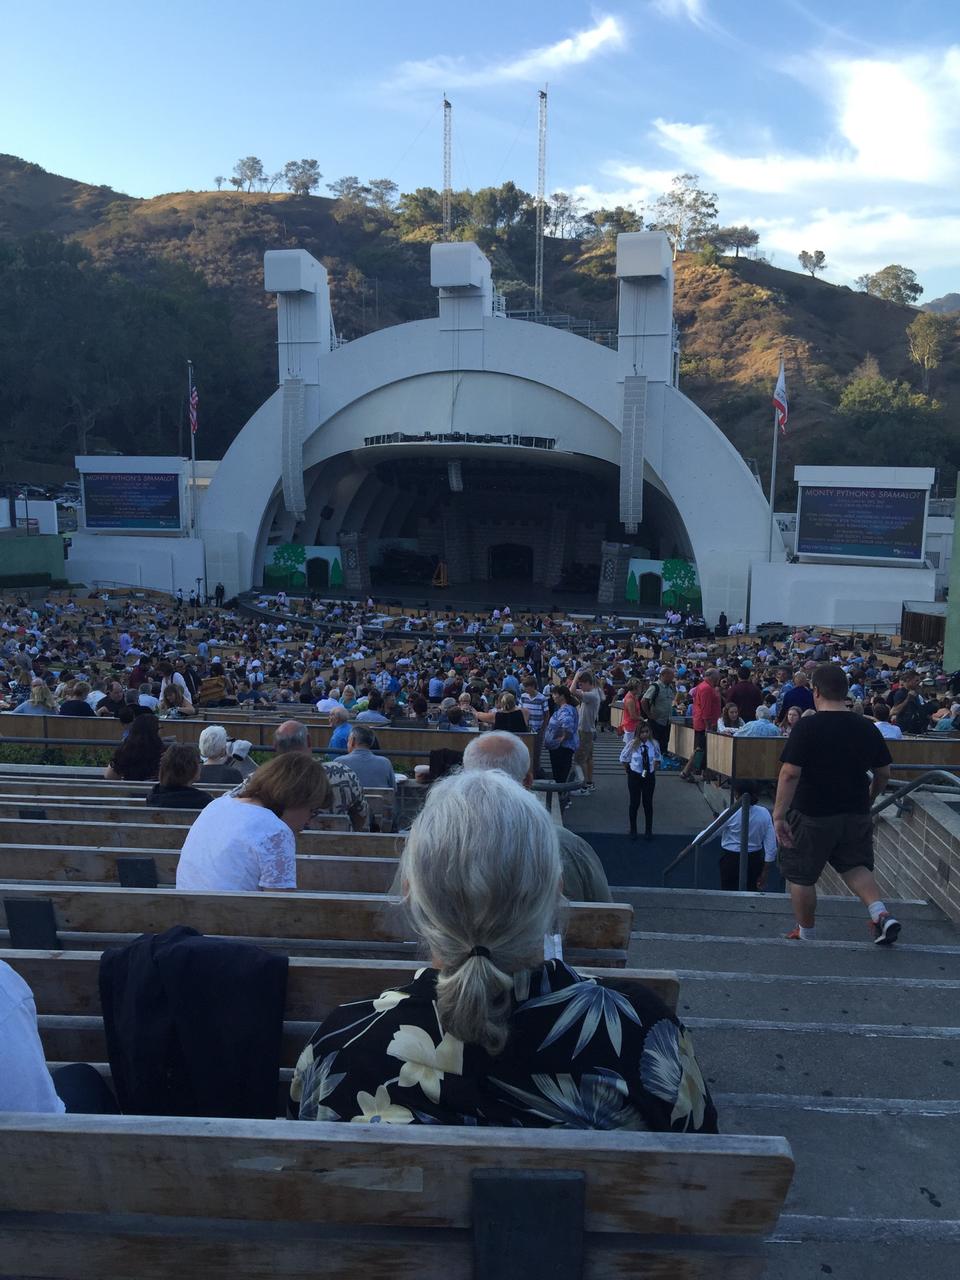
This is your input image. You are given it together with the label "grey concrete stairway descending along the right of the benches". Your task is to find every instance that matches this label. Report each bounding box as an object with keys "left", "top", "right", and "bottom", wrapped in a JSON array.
[{"left": 614, "top": 888, "right": 960, "bottom": 1280}]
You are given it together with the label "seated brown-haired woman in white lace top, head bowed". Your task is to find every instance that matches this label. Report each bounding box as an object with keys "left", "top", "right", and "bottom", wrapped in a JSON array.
[{"left": 177, "top": 751, "right": 330, "bottom": 892}]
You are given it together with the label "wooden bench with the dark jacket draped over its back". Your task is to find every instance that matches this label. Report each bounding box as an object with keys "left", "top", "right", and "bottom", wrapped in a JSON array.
[{"left": 0, "top": 948, "right": 680, "bottom": 1082}]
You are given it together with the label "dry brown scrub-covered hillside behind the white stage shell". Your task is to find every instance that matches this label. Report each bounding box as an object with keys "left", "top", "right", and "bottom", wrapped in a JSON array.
[{"left": 0, "top": 157, "right": 960, "bottom": 500}]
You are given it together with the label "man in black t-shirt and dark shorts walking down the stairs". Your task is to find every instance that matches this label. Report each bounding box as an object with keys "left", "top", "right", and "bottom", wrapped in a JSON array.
[{"left": 773, "top": 663, "right": 900, "bottom": 946}]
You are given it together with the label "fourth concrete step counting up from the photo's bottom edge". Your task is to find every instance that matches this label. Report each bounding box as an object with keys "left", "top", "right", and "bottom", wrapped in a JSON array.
[{"left": 678, "top": 970, "right": 960, "bottom": 1027}]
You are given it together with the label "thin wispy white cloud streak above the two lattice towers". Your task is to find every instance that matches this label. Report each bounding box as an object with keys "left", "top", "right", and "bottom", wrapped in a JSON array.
[{"left": 393, "top": 15, "right": 626, "bottom": 90}]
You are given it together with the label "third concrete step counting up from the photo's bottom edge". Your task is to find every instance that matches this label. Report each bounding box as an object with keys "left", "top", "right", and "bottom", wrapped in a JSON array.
[{"left": 684, "top": 1016, "right": 960, "bottom": 1100}]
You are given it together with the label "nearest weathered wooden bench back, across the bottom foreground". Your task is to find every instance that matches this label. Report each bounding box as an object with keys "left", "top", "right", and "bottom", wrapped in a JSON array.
[{"left": 0, "top": 1115, "right": 794, "bottom": 1280}]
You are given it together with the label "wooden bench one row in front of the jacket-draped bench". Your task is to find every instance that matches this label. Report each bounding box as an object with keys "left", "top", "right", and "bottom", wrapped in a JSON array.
[{"left": 0, "top": 881, "right": 634, "bottom": 968}]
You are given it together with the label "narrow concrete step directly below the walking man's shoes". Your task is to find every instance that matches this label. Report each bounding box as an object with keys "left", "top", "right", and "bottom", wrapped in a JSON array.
[{"left": 627, "top": 931, "right": 960, "bottom": 977}]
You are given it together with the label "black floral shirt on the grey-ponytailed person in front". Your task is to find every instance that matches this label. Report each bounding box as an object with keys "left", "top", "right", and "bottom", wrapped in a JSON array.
[{"left": 289, "top": 960, "right": 717, "bottom": 1133}]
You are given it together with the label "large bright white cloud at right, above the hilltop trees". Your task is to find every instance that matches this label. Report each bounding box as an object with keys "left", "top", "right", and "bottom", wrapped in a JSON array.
[{"left": 579, "top": 46, "right": 960, "bottom": 288}]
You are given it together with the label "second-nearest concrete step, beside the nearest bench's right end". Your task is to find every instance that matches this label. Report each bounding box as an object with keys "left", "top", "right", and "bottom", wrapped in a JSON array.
[{"left": 718, "top": 1098, "right": 960, "bottom": 1225}]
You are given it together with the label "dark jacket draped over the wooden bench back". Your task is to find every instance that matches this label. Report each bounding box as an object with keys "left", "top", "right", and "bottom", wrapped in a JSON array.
[{"left": 100, "top": 925, "right": 287, "bottom": 1120}]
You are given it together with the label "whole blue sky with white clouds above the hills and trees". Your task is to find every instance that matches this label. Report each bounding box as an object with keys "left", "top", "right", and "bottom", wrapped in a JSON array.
[{"left": 0, "top": 0, "right": 960, "bottom": 298}]
